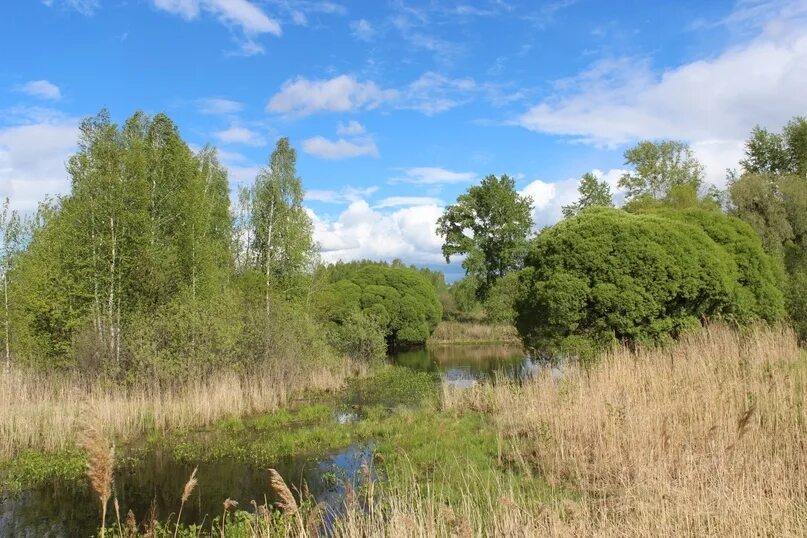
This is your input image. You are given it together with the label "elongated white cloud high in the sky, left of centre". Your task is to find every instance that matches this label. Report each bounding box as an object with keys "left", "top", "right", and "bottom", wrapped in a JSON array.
[{"left": 266, "top": 75, "right": 397, "bottom": 116}]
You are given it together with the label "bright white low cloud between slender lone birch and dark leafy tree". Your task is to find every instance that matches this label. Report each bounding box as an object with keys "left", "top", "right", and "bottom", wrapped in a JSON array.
[{"left": 310, "top": 200, "right": 444, "bottom": 263}]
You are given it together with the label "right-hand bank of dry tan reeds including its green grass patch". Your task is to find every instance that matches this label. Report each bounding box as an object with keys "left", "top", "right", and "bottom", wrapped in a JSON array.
[{"left": 113, "top": 320, "right": 807, "bottom": 537}]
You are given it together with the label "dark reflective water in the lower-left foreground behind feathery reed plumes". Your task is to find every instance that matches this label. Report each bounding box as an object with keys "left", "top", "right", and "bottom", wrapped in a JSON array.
[{"left": 0, "top": 445, "right": 372, "bottom": 538}]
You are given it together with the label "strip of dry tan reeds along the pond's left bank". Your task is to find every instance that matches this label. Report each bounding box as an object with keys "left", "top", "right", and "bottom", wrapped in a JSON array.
[{"left": 0, "top": 361, "right": 357, "bottom": 459}]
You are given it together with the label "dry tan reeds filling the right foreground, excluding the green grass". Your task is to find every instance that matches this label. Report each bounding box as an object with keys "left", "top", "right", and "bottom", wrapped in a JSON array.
[{"left": 445, "top": 326, "right": 807, "bottom": 536}]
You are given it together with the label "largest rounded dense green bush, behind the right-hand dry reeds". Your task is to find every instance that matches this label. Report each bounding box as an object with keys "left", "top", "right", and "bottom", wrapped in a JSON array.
[{"left": 516, "top": 208, "right": 784, "bottom": 354}]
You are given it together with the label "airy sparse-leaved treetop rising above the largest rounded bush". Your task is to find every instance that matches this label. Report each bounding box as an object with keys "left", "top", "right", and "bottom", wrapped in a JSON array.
[{"left": 619, "top": 140, "right": 703, "bottom": 200}]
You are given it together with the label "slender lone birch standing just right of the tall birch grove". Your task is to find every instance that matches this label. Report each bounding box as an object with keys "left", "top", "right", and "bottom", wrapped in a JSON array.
[{"left": 252, "top": 137, "right": 314, "bottom": 311}]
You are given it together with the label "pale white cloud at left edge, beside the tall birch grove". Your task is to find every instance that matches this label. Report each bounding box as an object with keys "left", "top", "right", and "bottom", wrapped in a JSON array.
[{"left": 0, "top": 110, "right": 78, "bottom": 211}]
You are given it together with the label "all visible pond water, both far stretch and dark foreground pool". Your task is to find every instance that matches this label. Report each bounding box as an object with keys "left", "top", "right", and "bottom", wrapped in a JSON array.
[{"left": 0, "top": 345, "right": 537, "bottom": 538}]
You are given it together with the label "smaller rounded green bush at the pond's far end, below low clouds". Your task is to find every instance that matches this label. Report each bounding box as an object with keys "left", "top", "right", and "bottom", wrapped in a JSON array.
[{"left": 315, "top": 263, "right": 442, "bottom": 345}]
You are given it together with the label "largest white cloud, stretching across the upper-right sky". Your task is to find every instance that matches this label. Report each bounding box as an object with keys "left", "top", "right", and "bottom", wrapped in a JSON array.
[{"left": 517, "top": 0, "right": 807, "bottom": 184}]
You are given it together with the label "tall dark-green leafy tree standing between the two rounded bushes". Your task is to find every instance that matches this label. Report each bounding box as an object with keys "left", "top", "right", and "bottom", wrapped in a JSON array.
[{"left": 437, "top": 175, "right": 533, "bottom": 299}]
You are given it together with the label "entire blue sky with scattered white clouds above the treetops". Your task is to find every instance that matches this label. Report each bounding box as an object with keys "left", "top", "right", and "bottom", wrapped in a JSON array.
[{"left": 0, "top": 0, "right": 807, "bottom": 279}]
